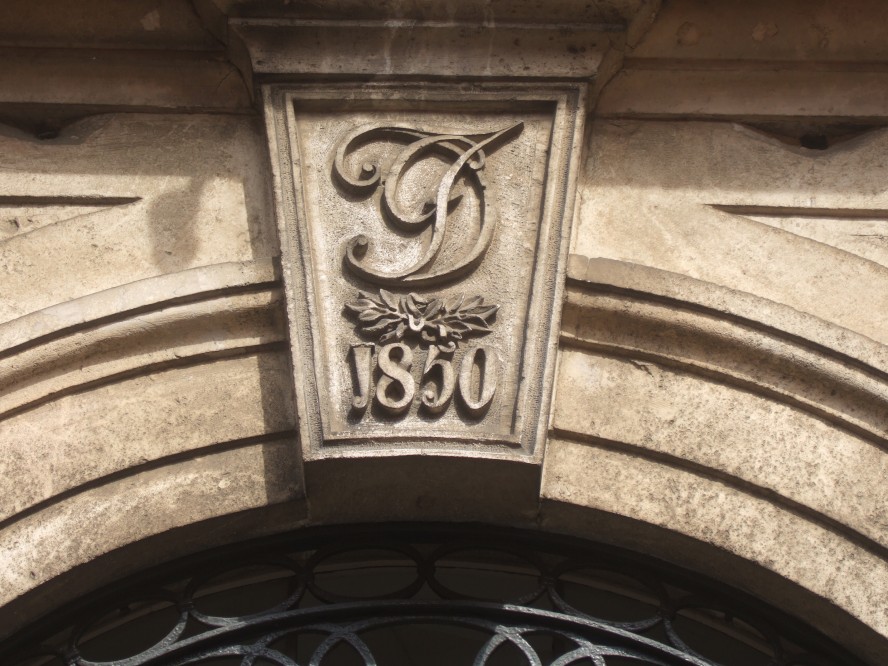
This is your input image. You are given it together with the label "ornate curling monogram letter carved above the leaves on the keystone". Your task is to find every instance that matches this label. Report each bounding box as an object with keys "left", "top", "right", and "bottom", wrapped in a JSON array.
[{"left": 333, "top": 122, "right": 524, "bottom": 286}]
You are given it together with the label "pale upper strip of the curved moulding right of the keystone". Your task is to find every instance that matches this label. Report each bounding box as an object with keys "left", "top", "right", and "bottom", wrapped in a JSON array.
[{"left": 568, "top": 254, "right": 888, "bottom": 382}]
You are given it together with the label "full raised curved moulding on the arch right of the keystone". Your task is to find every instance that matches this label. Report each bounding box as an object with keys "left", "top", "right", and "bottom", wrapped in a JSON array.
[{"left": 561, "top": 255, "right": 888, "bottom": 448}]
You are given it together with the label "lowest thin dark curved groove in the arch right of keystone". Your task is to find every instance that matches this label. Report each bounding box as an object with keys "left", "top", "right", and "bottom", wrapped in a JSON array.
[{"left": 551, "top": 427, "right": 888, "bottom": 561}]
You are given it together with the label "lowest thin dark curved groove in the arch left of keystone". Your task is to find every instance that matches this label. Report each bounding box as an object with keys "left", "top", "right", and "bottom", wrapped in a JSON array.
[{"left": 0, "top": 430, "right": 296, "bottom": 531}]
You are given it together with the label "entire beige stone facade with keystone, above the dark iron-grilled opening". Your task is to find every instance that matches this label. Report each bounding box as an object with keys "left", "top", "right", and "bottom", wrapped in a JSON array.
[{"left": 0, "top": 0, "right": 888, "bottom": 664}]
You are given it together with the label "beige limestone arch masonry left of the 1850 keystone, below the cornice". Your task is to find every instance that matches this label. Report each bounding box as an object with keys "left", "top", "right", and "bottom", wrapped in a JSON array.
[{"left": 0, "top": 114, "right": 303, "bottom": 633}]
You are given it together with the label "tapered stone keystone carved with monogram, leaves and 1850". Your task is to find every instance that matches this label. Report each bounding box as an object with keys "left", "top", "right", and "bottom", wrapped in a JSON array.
[{"left": 265, "top": 84, "right": 584, "bottom": 460}]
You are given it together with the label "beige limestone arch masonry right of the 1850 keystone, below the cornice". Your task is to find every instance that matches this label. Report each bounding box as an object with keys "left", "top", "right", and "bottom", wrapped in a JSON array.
[{"left": 541, "top": 118, "right": 888, "bottom": 663}]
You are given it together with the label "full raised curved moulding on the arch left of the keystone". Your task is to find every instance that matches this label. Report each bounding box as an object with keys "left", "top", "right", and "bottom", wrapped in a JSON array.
[{"left": 0, "top": 260, "right": 286, "bottom": 422}]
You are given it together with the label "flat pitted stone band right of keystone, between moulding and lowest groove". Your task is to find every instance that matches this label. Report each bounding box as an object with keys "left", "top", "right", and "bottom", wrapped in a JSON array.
[{"left": 552, "top": 350, "right": 888, "bottom": 544}]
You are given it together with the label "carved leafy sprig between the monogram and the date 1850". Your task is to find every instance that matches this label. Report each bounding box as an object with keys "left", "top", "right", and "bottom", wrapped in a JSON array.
[{"left": 345, "top": 289, "right": 499, "bottom": 352}]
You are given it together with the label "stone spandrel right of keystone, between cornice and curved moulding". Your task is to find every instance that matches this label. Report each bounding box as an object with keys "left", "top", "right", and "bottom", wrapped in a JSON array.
[{"left": 573, "top": 120, "right": 888, "bottom": 344}]
